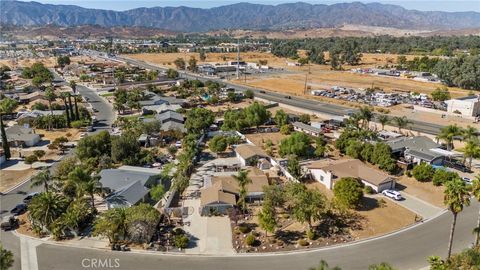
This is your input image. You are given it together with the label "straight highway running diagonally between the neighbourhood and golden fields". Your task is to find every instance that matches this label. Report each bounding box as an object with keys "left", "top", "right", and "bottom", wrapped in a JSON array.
[{"left": 118, "top": 57, "right": 443, "bottom": 135}]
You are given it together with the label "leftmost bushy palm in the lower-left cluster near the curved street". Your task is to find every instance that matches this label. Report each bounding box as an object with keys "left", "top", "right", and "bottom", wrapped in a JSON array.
[{"left": 28, "top": 192, "right": 68, "bottom": 230}]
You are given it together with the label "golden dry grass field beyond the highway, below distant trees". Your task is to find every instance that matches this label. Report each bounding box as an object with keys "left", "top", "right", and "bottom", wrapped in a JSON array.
[{"left": 128, "top": 52, "right": 468, "bottom": 97}]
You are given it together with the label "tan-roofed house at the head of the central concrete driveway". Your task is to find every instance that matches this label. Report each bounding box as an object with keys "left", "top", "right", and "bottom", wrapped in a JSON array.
[{"left": 200, "top": 172, "right": 269, "bottom": 215}]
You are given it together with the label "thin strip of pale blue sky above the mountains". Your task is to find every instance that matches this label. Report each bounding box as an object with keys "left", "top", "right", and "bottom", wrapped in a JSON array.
[{"left": 32, "top": 0, "right": 480, "bottom": 12}]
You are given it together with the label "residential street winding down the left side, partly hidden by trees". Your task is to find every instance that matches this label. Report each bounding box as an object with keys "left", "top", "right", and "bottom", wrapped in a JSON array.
[{"left": 0, "top": 72, "right": 115, "bottom": 270}]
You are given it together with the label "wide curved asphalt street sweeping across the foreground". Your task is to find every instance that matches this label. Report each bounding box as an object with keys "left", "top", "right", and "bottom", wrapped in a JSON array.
[{"left": 32, "top": 199, "right": 479, "bottom": 270}]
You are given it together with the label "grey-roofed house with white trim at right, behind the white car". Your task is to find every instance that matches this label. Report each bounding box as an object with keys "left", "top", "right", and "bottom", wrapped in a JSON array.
[{"left": 385, "top": 136, "right": 445, "bottom": 165}]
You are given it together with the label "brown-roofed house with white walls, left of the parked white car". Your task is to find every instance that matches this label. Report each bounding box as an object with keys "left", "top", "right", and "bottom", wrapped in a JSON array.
[{"left": 307, "top": 159, "right": 395, "bottom": 192}]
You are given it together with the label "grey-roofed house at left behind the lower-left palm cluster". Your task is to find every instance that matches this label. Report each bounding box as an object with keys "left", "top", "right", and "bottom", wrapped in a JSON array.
[{"left": 100, "top": 166, "right": 170, "bottom": 209}]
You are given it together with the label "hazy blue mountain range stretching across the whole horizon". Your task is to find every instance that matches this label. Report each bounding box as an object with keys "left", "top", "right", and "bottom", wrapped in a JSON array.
[{"left": 0, "top": 0, "right": 480, "bottom": 32}]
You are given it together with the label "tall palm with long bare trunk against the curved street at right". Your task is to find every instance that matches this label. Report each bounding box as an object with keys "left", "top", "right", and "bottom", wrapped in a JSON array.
[{"left": 443, "top": 178, "right": 470, "bottom": 259}]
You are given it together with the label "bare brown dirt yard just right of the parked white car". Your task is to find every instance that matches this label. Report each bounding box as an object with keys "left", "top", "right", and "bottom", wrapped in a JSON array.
[{"left": 397, "top": 176, "right": 445, "bottom": 208}]
